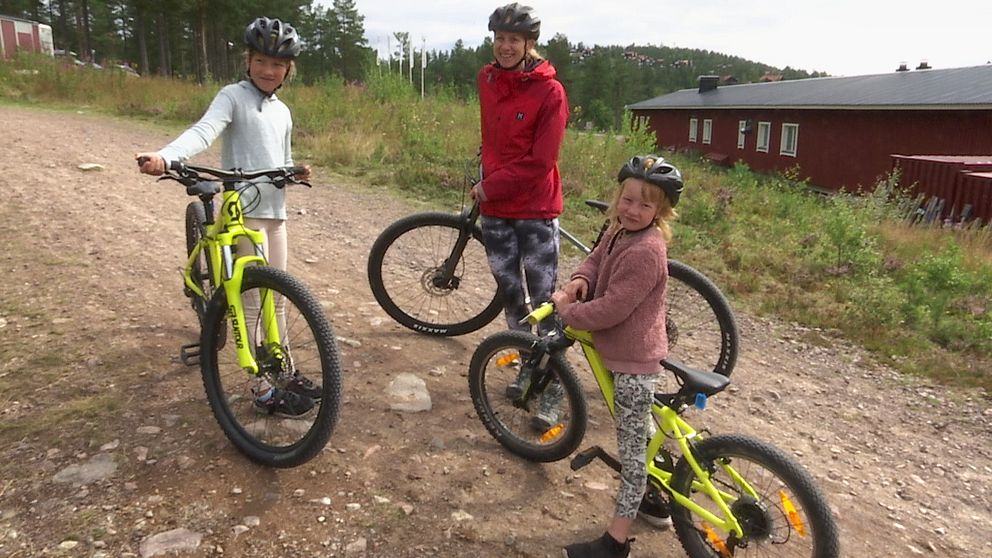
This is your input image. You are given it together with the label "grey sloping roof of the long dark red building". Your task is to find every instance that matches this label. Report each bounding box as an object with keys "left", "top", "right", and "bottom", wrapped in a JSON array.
[{"left": 627, "top": 64, "right": 992, "bottom": 110}]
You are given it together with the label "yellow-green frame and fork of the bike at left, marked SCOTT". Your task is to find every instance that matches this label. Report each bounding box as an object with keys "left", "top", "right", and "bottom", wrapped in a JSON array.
[{"left": 183, "top": 188, "right": 282, "bottom": 375}]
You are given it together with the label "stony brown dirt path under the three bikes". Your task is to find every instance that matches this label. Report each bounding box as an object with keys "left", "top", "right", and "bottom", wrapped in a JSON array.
[{"left": 0, "top": 106, "right": 992, "bottom": 558}]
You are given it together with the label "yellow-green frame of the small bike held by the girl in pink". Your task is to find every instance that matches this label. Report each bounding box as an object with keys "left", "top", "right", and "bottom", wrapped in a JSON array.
[{"left": 527, "top": 303, "right": 744, "bottom": 537}]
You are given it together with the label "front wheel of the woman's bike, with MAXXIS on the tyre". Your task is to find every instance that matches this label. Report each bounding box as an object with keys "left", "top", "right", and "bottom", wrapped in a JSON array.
[{"left": 368, "top": 213, "right": 503, "bottom": 336}]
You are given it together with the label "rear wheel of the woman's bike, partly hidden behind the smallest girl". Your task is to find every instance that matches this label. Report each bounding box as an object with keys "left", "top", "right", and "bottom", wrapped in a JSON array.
[{"left": 665, "top": 259, "right": 740, "bottom": 376}]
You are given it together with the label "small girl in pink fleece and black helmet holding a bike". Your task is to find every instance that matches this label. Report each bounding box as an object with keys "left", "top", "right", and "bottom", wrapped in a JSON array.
[{"left": 551, "top": 155, "right": 683, "bottom": 558}]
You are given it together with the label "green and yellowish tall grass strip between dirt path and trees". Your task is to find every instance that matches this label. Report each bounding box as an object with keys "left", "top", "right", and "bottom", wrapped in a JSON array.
[{"left": 0, "top": 57, "right": 992, "bottom": 389}]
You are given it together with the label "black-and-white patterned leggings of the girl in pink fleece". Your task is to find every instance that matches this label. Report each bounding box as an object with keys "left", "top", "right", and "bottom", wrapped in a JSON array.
[{"left": 613, "top": 372, "right": 658, "bottom": 519}]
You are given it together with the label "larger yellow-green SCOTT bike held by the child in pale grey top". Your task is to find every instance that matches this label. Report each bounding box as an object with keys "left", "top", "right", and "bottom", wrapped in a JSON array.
[{"left": 151, "top": 161, "right": 341, "bottom": 467}]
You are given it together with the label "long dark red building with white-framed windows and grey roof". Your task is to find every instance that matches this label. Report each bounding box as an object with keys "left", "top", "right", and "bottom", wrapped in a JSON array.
[{"left": 628, "top": 64, "right": 992, "bottom": 200}]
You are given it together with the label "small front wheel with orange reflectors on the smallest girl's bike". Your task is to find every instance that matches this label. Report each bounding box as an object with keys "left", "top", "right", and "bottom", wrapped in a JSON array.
[{"left": 468, "top": 331, "right": 588, "bottom": 463}]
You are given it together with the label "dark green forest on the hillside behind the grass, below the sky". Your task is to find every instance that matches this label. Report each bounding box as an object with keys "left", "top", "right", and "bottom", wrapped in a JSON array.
[{"left": 0, "top": 0, "right": 825, "bottom": 130}]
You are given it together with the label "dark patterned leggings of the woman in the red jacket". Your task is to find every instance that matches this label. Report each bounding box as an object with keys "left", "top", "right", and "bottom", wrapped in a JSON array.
[{"left": 482, "top": 216, "right": 560, "bottom": 333}]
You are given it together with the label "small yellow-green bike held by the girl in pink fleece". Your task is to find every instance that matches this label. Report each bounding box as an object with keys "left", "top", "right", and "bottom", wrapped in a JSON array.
[{"left": 469, "top": 303, "right": 840, "bottom": 558}]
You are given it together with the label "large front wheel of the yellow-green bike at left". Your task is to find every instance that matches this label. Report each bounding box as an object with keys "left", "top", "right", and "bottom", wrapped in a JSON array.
[{"left": 200, "top": 266, "right": 341, "bottom": 467}]
